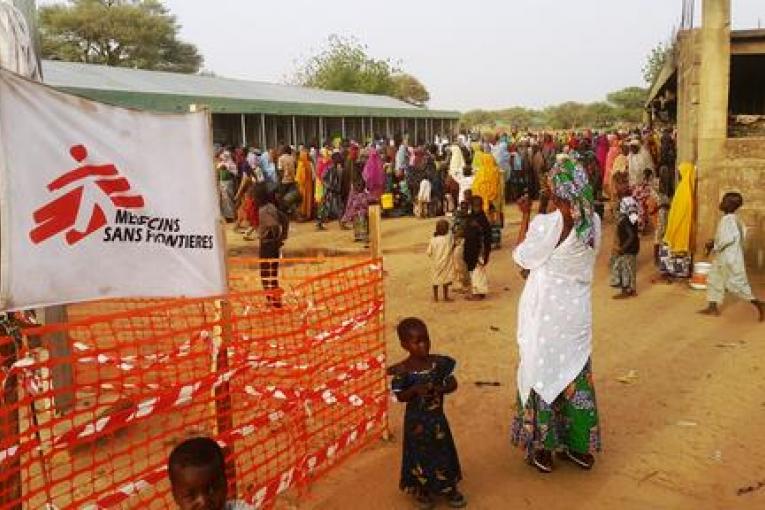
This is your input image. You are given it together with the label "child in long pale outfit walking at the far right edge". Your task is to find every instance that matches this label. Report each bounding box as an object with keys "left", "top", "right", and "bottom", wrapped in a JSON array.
[{"left": 700, "top": 192, "right": 765, "bottom": 322}]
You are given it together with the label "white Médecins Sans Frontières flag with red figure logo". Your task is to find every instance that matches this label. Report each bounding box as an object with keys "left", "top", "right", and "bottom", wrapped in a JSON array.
[{"left": 0, "top": 69, "right": 226, "bottom": 310}]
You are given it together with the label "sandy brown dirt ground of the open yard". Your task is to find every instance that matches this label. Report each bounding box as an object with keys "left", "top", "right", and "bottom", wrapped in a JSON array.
[{"left": 231, "top": 208, "right": 765, "bottom": 510}]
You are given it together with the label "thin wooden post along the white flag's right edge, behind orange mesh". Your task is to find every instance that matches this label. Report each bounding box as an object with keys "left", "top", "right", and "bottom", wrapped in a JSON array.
[{"left": 189, "top": 105, "right": 237, "bottom": 499}]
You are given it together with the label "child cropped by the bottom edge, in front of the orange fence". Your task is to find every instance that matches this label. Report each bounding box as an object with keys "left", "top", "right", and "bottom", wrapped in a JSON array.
[{"left": 167, "top": 437, "right": 254, "bottom": 510}]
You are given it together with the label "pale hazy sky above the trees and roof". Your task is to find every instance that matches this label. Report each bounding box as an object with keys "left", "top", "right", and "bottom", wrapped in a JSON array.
[{"left": 38, "top": 0, "right": 765, "bottom": 110}]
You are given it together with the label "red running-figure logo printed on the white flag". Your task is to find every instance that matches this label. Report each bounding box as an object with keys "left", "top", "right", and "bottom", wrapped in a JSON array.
[{"left": 29, "top": 145, "right": 144, "bottom": 246}]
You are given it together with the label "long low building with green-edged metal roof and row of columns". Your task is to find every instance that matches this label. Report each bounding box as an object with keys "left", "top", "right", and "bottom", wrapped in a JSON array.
[{"left": 42, "top": 60, "right": 459, "bottom": 147}]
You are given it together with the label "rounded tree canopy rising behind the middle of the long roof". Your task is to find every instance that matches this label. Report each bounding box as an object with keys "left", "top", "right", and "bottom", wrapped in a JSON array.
[{"left": 292, "top": 34, "right": 430, "bottom": 106}]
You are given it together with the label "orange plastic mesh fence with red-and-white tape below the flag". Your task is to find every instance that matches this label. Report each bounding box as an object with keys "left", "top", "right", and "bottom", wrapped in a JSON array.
[{"left": 0, "top": 258, "right": 387, "bottom": 509}]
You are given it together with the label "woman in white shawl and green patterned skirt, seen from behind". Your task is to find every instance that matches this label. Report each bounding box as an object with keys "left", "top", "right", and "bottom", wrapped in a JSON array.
[{"left": 512, "top": 156, "right": 601, "bottom": 473}]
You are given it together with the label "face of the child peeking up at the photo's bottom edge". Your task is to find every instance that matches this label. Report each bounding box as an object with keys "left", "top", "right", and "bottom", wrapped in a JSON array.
[{"left": 172, "top": 466, "right": 226, "bottom": 510}]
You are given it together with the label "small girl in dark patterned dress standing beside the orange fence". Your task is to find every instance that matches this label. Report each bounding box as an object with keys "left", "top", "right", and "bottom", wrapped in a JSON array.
[{"left": 388, "top": 317, "right": 467, "bottom": 509}]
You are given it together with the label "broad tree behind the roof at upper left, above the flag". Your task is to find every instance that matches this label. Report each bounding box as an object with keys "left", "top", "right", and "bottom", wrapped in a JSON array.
[{"left": 40, "top": 0, "right": 203, "bottom": 73}]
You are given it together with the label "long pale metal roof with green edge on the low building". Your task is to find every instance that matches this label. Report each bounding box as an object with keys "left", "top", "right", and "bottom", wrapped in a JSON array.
[{"left": 42, "top": 60, "right": 460, "bottom": 119}]
